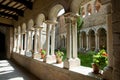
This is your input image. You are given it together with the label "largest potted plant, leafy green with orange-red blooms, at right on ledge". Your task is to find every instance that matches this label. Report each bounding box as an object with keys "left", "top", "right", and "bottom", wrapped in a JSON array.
[{"left": 92, "top": 49, "right": 108, "bottom": 74}]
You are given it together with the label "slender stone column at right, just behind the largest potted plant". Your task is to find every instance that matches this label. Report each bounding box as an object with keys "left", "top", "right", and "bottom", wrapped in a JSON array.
[{"left": 102, "top": 0, "right": 113, "bottom": 80}]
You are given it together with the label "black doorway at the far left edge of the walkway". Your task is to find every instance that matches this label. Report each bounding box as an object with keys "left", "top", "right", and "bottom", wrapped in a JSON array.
[{"left": 0, "top": 32, "right": 7, "bottom": 60}]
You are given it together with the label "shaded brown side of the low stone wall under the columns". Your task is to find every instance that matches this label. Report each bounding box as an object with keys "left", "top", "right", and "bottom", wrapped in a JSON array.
[{"left": 12, "top": 53, "right": 97, "bottom": 80}]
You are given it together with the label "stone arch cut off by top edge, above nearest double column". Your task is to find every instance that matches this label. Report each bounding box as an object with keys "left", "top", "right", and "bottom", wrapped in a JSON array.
[{"left": 70, "top": 0, "right": 81, "bottom": 13}]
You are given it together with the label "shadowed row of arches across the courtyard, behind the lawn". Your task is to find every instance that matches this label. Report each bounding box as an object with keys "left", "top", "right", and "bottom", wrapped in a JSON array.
[{"left": 80, "top": 25, "right": 107, "bottom": 51}]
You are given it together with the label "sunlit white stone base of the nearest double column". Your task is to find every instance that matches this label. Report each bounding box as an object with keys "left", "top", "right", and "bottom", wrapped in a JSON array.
[{"left": 64, "top": 58, "right": 80, "bottom": 69}]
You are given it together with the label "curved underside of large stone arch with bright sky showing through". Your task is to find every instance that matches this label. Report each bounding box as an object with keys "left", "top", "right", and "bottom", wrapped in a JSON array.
[{"left": 49, "top": 4, "right": 64, "bottom": 21}]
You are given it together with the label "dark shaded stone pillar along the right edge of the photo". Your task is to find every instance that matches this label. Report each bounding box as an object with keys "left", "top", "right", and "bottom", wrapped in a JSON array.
[{"left": 112, "top": 0, "right": 120, "bottom": 80}]
